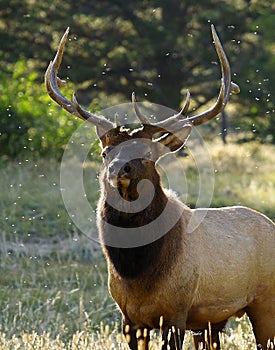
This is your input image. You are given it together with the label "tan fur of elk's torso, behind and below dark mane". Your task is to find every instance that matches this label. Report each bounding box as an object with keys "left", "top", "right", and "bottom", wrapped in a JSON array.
[{"left": 101, "top": 191, "right": 275, "bottom": 349}]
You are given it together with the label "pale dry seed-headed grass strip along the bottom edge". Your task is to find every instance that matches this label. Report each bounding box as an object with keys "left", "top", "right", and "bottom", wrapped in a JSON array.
[{"left": 0, "top": 319, "right": 264, "bottom": 350}]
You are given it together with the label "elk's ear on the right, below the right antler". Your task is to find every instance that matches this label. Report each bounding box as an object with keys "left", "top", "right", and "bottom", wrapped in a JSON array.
[{"left": 154, "top": 125, "right": 192, "bottom": 153}]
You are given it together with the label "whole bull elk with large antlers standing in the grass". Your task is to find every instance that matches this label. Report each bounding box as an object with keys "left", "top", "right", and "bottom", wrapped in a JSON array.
[{"left": 46, "top": 27, "right": 275, "bottom": 350}]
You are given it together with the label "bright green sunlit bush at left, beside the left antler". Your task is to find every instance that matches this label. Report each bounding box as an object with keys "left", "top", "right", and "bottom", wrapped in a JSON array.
[{"left": 0, "top": 59, "right": 101, "bottom": 159}]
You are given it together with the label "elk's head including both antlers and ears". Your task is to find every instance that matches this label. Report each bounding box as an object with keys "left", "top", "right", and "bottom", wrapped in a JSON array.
[{"left": 45, "top": 25, "right": 239, "bottom": 201}]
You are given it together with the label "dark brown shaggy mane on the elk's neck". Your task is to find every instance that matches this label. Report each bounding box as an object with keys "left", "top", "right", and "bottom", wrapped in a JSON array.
[{"left": 99, "top": 172, "right": 183, "bottom": 279}]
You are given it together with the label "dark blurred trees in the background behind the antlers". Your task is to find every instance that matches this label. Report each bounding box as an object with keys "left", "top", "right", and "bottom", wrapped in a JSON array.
[{"left": 0, "top": 0, "right": 275, "bottom": 157}]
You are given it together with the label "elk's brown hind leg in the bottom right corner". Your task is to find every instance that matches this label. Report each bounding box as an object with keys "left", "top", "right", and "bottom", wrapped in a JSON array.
[{"left": 246, "top": 299, "right": 275, "bottom": 350}]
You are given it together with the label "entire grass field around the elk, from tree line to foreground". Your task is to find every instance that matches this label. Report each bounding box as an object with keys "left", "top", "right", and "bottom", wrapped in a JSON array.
[{"left": 0, "top": 142, "right": 275, "bottom": 350}]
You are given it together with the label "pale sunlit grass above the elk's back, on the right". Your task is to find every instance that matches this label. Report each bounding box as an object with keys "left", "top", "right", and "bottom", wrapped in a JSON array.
[{"left": 182, "top": 142, "right": 275, "bottom": 220}]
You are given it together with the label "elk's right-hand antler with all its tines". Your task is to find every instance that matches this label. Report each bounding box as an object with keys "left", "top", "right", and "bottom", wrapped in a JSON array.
[{"left": 132, "top": 24, "right": 240, "bottom": 131}]
